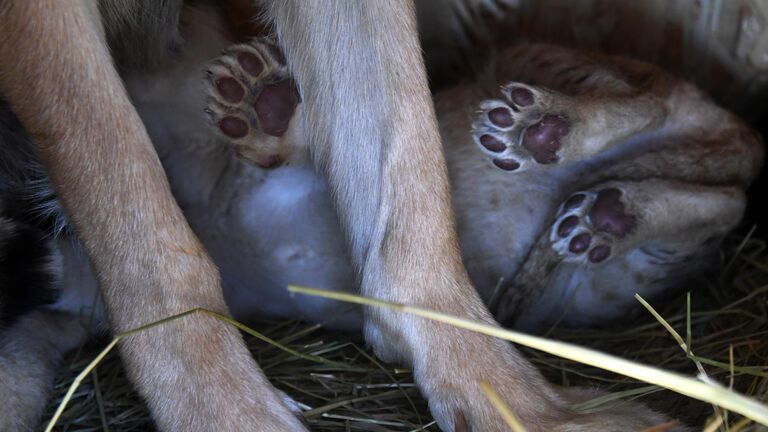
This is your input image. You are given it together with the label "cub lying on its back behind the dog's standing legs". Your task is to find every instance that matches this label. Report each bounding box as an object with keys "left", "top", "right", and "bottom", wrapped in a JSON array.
[{"left": 203, "top": 39, "right": 763, "bottom": 329}]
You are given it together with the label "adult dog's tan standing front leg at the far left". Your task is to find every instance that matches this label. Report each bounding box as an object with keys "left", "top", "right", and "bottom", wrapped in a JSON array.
[{"left": 0, "top": 0, "right": 303, "bottom": 432}]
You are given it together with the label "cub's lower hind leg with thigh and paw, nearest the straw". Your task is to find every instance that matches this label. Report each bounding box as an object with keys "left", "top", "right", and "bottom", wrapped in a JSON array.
[{"left": 508, "top": 179, "right": 746, "bottom": 328}]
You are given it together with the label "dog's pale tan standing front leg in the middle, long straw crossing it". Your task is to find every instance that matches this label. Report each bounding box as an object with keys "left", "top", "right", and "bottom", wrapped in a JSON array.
[{"left": 269, "top": 0, "right": 588, "bottom": 432}]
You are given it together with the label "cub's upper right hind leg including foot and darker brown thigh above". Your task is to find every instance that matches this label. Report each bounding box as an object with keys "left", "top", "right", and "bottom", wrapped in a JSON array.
[{"left": 472, "top": 44, "right": 671, "bottom": 171}]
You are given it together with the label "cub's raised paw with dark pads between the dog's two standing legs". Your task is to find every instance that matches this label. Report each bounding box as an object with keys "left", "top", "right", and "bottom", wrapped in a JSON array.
[{"left": 205, "top": 38, "right": 299, "bottom": 168}]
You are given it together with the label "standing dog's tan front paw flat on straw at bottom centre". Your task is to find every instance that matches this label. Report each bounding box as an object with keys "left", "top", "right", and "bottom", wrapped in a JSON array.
[{"left": 421, "top": 335, "right": 685, "bottom": 432}]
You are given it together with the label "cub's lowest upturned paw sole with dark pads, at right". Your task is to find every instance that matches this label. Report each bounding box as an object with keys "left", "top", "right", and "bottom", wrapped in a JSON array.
[{"left": 550, "top": 188, "right": 637, "bottom": 264}]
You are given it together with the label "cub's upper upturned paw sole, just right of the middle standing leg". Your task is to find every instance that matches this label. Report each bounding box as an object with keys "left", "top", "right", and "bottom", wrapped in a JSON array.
[{"left": 472, "top": 82, "right": 572, "bottom": 171}]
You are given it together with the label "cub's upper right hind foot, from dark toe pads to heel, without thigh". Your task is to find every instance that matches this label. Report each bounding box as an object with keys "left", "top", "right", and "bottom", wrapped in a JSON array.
[{"left": 472, "top": 82, "right": 666, "bottom": 171}]
